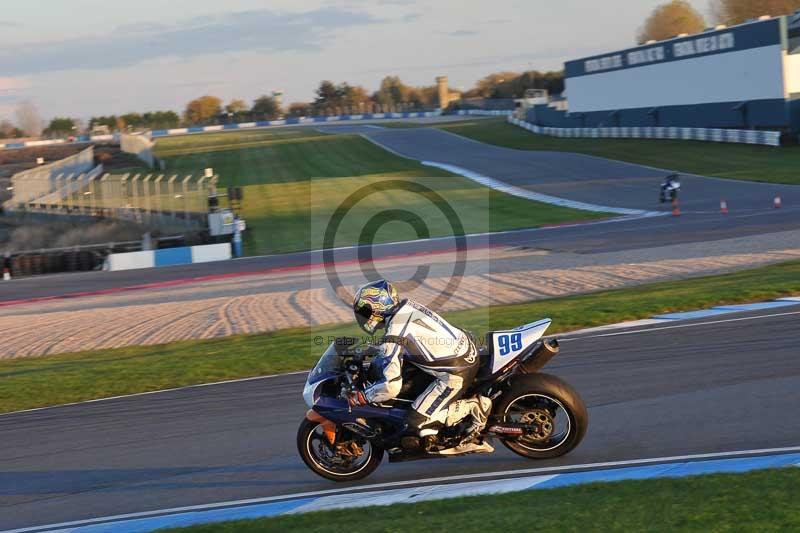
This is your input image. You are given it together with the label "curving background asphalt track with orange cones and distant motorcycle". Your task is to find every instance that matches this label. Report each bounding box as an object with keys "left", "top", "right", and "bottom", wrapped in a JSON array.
[{"left": 0, "top": 125, "right": 800, "bottom": 304}]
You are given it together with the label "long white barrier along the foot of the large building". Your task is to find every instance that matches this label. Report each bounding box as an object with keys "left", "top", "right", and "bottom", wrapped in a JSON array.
[{"left": 508, "top": 116, "right": 781, "bottom": 146}]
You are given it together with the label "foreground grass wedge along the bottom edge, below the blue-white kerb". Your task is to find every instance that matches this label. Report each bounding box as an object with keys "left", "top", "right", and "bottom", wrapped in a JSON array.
[{"left": 170, "top": 468, "right": 800, "bottom": 533}]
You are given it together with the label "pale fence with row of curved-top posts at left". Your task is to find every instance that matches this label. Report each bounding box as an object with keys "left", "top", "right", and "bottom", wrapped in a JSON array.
[{"left": 3, "top": 170, "right": 217, "bottom": 227}]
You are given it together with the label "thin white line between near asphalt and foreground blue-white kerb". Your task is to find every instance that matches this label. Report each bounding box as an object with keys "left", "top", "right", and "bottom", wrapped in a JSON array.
[{"left": 10, "top": 446, "right": 800, "bottom": 533}]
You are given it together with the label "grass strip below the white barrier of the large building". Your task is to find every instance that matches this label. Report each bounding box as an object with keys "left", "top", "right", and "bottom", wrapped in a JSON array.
[{"left": 437, "top": 119, "right": 800, "bottom": 185}]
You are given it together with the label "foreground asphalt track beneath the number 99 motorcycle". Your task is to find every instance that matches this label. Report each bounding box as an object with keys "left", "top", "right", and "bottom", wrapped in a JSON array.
[{"left": 0, "top": 305, "right": 800, "bottom": 529}]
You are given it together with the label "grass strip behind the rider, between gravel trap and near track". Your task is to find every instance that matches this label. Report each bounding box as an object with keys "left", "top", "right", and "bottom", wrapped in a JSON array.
[{"left": 0, "top": 261, "right": 800, "bottom": 412}]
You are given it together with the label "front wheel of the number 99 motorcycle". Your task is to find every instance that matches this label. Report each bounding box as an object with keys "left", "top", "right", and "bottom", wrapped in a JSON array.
[{"left": 297, "top": 419, "right": 383, "bottom": 481}]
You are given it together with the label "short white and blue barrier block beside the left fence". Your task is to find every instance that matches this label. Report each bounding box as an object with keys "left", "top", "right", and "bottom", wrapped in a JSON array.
[{"left": 103, "top": 243, "right": 231, "bottom": 270}]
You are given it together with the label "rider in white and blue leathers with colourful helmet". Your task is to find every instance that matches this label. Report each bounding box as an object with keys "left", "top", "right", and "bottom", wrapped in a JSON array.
[{"left": 349, "top": 280, "right": 492, "bottom": 453}]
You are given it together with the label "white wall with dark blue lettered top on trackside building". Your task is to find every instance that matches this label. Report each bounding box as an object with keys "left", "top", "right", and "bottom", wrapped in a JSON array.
[{"left": 565, "top": 18, "right": 787, "bottom": 113}]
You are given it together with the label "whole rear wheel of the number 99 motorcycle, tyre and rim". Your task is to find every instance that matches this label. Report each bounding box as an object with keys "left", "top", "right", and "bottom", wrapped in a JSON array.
[{"left": 494, "top": 374, "right": 589, "bottom": 459}]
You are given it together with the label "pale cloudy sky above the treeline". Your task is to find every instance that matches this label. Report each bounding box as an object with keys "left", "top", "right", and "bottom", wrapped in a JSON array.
[{"left": 0, "top": 0, "right": 707, "bottom": 119}]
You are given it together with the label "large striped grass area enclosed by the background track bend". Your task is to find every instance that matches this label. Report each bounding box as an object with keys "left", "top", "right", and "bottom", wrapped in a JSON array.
[{"left": 157, "top": 128, "right": 608, "bottom": 255}]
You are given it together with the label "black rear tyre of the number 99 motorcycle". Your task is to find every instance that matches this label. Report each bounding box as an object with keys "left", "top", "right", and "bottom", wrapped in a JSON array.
[{"left": 493, "top": 374, "right": 589, "bottom": 459}]
